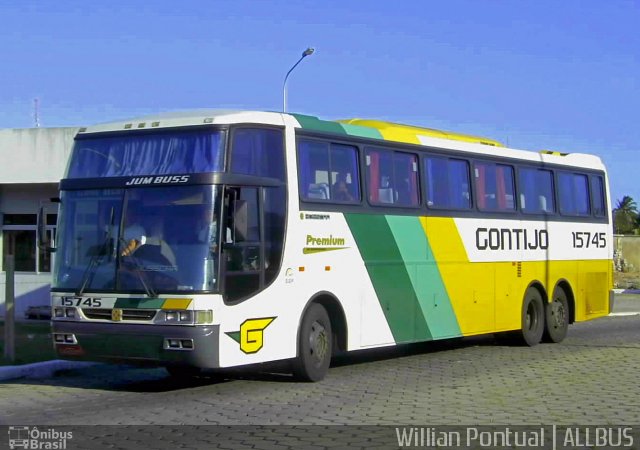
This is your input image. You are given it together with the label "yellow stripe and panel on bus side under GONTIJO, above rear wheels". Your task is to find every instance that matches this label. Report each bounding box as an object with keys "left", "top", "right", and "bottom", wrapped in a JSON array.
[{"left": 420, "top": 217, "right": 612, "bottom": 335}]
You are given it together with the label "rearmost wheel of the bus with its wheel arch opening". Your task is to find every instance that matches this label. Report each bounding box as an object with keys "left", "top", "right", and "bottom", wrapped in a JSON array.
[{"left": 542, "top": 280, "right": 575, "bottom": 343}]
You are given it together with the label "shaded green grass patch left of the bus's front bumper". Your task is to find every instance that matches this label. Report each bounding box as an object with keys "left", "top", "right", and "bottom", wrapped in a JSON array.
[{"left": 0, "top": 320, "right": 57, "bottom": 366}]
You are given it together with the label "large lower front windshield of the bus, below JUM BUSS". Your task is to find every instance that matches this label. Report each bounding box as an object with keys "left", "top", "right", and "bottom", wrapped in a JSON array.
[{"left": 52, "top": 186, "right": 221, "bottom": 296}]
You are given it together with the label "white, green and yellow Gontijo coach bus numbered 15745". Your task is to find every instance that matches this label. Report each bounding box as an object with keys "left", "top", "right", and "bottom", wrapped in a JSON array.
[{"left": 41, "top": 110, "right": 613, "bottom": 381}]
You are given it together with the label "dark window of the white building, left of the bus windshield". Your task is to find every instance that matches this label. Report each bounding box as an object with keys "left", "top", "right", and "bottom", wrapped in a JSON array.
[{"left": 2, "top": 214, "right": 57, "bottom": 272}]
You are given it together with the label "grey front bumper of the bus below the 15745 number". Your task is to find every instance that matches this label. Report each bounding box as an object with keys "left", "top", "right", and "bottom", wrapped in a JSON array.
[{"left": 52, "top": 320, "right": 220, "bottom": 368}]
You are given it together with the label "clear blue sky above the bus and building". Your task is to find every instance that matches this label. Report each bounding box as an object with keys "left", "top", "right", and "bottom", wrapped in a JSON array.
[{"left": 0, "top": 0, "right": 640, "bottom": 206}]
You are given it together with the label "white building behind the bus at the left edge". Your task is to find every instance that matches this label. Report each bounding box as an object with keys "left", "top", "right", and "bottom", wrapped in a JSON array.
[{"left": 0, "top": 128, "right": 79, "bottom": 319}]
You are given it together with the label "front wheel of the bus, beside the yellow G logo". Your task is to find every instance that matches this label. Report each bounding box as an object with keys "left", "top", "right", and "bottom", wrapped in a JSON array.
[{"left": 292, "top": 303, "right": 333, "bottom": 381}]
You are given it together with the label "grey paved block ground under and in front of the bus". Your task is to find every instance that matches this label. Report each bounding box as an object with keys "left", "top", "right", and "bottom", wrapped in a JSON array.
[{"left": 0, "top": 295, "right": 640, "bottom": 448}]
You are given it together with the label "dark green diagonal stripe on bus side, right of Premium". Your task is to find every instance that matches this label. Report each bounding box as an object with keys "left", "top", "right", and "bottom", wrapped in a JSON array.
[{"left": 345, "top": 214, "right": 432, "bottom": 342}]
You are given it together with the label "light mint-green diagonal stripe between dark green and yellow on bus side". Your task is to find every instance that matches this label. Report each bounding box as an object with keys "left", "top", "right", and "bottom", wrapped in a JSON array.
[{"left": 387, "top": 216, "right": 462, "bottom": 339}]
